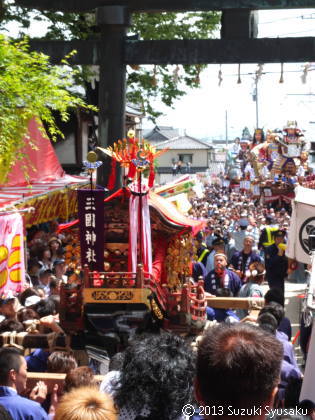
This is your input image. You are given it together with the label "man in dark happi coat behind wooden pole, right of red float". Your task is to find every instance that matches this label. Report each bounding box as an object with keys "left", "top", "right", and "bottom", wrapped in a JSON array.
[{"left": 205, "top": 253, "right": 242, "bottom": 296}]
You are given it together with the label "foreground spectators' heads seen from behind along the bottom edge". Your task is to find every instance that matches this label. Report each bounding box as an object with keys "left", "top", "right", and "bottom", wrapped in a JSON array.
[{"left": 0, "top": 322, "right": 315, "bottom": 420}]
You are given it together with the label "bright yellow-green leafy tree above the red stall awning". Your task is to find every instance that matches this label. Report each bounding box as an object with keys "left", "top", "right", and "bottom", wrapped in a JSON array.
[{"left": 0, "top": 35, "right": 95, "bottom": 183}]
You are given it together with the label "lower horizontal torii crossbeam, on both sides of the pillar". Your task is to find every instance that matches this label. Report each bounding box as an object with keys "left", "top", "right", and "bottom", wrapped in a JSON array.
[{"left": 30, "top": 37, "right": 315, "bottom": 65}]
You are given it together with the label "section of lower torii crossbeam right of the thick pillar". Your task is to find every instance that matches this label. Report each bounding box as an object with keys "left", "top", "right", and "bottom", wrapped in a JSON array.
[{"left": 125, "top": 37, "right": 315, "bottom": 64}]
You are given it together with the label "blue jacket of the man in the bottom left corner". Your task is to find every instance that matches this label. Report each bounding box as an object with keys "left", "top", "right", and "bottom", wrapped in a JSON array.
[{"left": 0, "top": 386, "right": 49, "bottom": 420}]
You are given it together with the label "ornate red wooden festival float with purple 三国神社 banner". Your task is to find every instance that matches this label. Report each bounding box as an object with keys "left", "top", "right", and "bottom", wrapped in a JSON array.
[{"left": 59, "top": 133, "right": 206, "bottom": 354}]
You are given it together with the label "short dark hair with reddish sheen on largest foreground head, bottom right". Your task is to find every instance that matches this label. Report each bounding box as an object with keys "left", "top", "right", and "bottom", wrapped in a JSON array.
[{"left": 196, "top": 323, "right": 283, "bottom": 408}]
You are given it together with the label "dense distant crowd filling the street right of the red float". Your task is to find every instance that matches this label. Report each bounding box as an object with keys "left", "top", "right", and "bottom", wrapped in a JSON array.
[{"left": 190, "top": 184, "right": 306, "bottom": 292}]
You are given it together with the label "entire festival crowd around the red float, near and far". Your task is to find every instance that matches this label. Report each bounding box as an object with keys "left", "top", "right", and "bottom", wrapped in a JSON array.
[{"left": 0, "top": 184, "right": 315, "bottom": 420}]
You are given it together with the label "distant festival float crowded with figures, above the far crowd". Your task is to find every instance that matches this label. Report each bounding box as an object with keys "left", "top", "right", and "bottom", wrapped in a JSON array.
[{"left": 226, "top": 121, "right": 314, "bottom": 206}]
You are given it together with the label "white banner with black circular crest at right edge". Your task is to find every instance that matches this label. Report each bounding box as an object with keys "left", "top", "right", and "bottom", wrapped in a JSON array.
[{"left": 286, "top": 186, "right": 315, "bottom": 264}]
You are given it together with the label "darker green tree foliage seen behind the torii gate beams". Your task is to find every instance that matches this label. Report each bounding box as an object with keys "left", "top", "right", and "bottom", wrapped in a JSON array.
[{"left": 0, "top": 0, "right": 220, "bottom": 119}]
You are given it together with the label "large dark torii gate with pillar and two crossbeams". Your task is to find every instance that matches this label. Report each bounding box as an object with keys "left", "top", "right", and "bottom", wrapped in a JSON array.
[{"left": 15, "top": 0, "right": 315, "bottom": 188}]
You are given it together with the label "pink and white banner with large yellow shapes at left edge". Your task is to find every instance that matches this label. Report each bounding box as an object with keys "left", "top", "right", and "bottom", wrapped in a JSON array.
[{"left": 0, "top": 213, "right": 25, "bottom": 295}]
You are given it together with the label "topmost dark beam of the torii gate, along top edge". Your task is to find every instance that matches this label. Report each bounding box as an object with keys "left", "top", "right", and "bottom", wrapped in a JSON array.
[{"left": 15, "top": 0, "right": 315, "bottom": 12}]
